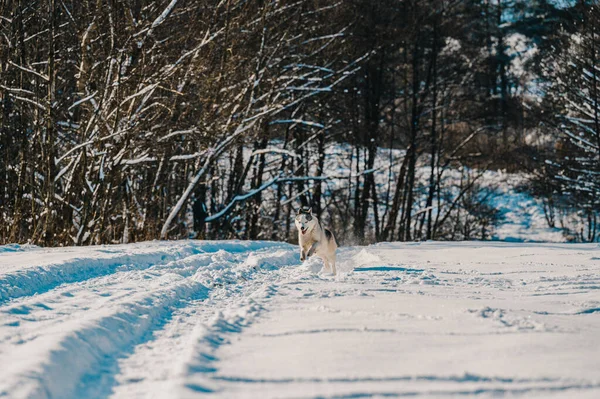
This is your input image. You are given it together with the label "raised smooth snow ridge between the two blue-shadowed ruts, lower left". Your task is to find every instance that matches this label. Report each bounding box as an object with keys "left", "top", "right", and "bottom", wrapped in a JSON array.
[{"left": 0, "top": 275, "right": 208, "bottom": 398}]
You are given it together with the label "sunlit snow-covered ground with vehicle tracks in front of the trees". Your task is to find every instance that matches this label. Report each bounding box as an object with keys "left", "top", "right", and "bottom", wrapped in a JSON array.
[{"left": 0, "top": 241, "right": 600, "bottom": 398}]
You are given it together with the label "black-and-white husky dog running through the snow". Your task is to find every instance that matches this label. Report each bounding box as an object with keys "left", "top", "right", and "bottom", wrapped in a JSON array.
[{"left": 295, "top": 208, "right": 337, "bottom": 275}]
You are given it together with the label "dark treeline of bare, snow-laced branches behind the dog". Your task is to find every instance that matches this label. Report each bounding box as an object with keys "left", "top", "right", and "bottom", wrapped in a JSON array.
[{"left": 0, "top": 0, "right": 600, "bottom": 245}]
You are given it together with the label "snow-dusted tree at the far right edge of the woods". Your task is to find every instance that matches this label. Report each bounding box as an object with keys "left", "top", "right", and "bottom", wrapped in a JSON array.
[{"left": 534, "top": 1, "right": 600, "bottom": 241}]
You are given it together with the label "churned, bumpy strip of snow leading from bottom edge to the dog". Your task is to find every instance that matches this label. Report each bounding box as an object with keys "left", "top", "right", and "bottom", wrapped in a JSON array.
[{"left": 106, "top": 246, "right": 299, "bottom": 398}]
